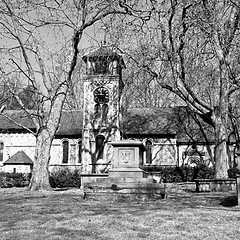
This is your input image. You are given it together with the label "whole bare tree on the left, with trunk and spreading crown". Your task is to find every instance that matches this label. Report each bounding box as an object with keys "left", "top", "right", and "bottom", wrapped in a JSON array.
[{"left": 0, "top": 0, "right": 131, "bottom": 190}]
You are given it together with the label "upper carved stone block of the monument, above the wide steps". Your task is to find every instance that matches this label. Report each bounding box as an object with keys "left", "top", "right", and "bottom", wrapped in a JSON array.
[{"left": 109, "top": 140, "right": 145, "bottom": 182}]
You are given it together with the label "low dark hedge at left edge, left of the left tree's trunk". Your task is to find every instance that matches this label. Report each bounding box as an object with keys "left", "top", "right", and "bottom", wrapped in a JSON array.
[{"left": 0, "top": 172, "right": 31, "bottom": 188}]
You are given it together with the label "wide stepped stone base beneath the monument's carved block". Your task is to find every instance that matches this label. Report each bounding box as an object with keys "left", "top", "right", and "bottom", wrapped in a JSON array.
[{"left": 84, "top": 169, "right": 166, "bottom": 201}]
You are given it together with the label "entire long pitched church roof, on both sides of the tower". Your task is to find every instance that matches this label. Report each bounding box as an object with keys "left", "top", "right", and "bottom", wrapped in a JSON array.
[{"left": 0, "top": 107, "right": 213, "bottom": 142}]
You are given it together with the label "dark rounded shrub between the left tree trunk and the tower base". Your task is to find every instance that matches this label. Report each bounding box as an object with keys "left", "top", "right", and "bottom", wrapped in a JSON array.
[{"left": 50, "top": 169, "right": 81, "bottom": 188}]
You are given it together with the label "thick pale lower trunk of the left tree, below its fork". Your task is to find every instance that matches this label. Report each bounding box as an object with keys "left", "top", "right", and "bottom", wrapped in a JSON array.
[{"left": 29, "top": 129, "right": 53, "bottom": 191}]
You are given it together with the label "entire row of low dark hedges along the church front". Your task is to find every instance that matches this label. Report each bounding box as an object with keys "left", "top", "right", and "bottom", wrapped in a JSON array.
[{"left": 0, "top": 165, "right": 239, "bottom": 188}]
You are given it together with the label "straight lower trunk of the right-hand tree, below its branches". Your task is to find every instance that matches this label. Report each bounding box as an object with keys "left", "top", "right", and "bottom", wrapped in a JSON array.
[{"left": 214, "top": 114, "right": 228, "bottom": 178}]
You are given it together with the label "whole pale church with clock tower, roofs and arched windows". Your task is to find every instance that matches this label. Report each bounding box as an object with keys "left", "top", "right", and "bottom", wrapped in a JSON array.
[{"left": 0, "top": 46, "right": 217, "bottom": 173}]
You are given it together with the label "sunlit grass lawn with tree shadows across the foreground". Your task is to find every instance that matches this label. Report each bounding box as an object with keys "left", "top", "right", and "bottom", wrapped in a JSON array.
[{"left": 0, "top": 188, "right": 240, "bottom": 240}]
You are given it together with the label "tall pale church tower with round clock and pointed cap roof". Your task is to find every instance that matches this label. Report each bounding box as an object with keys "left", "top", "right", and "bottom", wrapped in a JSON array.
[{"left": 82, "top": 46, "right": 125, "bottom": 173}]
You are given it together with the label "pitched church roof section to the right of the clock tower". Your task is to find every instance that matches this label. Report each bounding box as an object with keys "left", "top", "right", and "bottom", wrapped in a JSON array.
[{"left": 120, "top": 106, "right": 214, "bottom": 143}]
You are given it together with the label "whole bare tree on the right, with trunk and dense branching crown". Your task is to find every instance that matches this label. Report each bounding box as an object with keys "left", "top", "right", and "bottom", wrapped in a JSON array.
[{"left": 113, "top": 0, "right": 240, "bottom": 178}]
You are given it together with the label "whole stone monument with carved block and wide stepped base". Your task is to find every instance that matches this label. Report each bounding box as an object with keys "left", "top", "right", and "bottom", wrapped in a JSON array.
[{"left": 84, "top": 140, "right": 165, "bottom": 199}]
